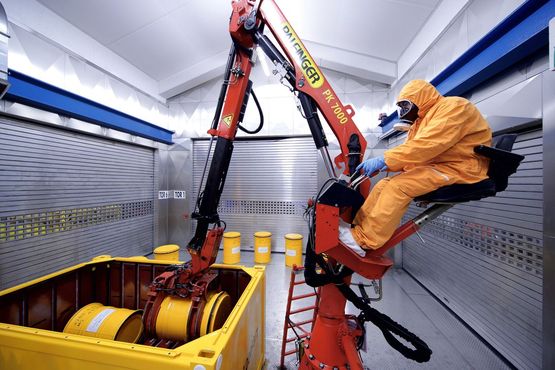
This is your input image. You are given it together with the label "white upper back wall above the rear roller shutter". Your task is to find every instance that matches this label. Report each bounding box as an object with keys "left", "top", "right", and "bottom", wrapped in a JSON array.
[{"left": 168, "top": 65, "right": 389, "bottom": 141}]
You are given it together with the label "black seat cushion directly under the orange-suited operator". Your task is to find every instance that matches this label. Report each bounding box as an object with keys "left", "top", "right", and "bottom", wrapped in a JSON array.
[{"left": 414, "top": 178, "right": 495, "bottom": 203}]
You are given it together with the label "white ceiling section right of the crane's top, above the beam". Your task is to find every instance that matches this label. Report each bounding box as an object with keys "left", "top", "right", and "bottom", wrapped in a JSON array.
[{"left": 276, "top": 0, "right": 439, "bottom": 61}]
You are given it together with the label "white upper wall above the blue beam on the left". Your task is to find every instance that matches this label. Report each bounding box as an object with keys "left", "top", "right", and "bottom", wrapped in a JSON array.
[{"left": 2, "top": 0, "right": 186, "bottom": 130}]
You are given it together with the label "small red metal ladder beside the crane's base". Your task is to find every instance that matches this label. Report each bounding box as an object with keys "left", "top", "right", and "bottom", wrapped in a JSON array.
[{"left": 280, "top": 265, "right": 320, "bottom": 369}]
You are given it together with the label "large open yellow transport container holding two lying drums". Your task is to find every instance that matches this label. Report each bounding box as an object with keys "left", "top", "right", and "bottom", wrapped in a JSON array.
[{"left": 0, "top": 256, "right": 265, "bottom": 370}]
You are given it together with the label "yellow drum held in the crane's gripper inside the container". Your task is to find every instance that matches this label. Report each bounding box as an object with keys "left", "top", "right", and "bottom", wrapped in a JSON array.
[{"left": 156, "top": 291, "right": 233, "bottom": 342}]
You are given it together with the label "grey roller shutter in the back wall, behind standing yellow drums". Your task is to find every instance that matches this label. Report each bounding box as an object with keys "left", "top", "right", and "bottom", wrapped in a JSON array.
[{"left": 193, "top": 137, "right": 318, "bottom": 252}]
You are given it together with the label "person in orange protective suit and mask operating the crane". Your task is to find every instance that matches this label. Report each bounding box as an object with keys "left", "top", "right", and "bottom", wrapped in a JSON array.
[{"left": 339, "top": 80, "right": 491, "bottom": 256}]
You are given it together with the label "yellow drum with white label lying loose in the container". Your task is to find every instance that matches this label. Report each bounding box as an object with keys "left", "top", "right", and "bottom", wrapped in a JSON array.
[{"left": 64, "top": 303, "right": 143, "bottom": 343}]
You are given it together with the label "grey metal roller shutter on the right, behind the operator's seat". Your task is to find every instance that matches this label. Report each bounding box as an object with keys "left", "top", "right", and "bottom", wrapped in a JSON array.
[{"left": 403, "top": 130, "right": 543, "bottom": 369}]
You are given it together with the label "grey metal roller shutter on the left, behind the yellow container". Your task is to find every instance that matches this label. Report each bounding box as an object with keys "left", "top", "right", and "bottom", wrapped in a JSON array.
[{"left": 0, "top": 117, "right": 155, "bottom": 289}]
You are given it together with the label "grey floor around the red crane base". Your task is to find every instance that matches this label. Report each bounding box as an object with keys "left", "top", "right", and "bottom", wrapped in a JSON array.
[{"left": 214, "top": 251, "right": 508, "bottom": 370}]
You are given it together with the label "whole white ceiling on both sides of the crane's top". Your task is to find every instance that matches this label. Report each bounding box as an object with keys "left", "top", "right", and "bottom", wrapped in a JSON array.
[{"left": 33, "top": 0, "right": 442, "bottom": 96}]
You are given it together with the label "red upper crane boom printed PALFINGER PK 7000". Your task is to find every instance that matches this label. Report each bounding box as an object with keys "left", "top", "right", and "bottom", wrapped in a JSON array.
[{"left": 224, "top": 0, "right": 366, "bottom": 175}]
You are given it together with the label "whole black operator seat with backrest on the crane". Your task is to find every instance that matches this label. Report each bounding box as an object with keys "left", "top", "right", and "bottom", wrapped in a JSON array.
[{"left": 414, "top": 134, "right": 524, "bottom": 204}]
